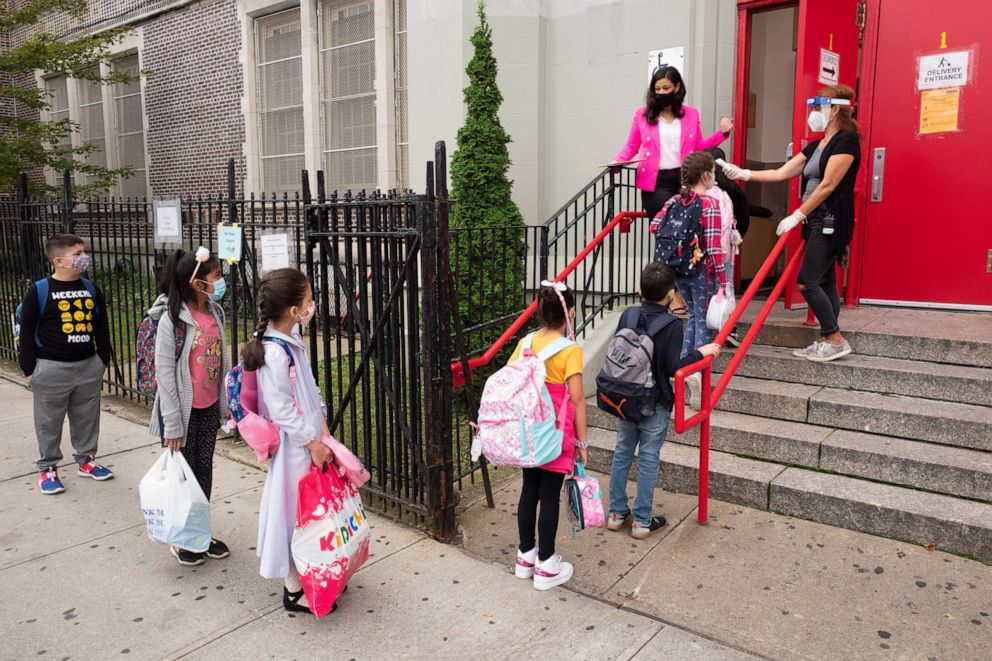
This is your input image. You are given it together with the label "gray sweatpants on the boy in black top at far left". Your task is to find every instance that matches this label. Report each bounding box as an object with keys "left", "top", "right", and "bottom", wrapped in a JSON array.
[{"left": 31, "top": 356, "right": 104, "bottom": 471}]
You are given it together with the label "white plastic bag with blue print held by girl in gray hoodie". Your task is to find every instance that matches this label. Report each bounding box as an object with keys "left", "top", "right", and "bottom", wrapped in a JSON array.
[{"left": 138, "top": 450, "right": 210, "bottom": 553}]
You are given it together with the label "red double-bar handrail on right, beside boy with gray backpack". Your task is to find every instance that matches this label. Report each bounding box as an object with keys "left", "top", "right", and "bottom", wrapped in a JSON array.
[{"left": 675, "top": 229, "right": 806, "bottom": 525}]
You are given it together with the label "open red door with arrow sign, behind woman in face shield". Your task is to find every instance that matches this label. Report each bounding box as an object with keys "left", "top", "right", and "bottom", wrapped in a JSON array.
[{"left": 785, "top": 0, "right": 860, "bottom": 307}]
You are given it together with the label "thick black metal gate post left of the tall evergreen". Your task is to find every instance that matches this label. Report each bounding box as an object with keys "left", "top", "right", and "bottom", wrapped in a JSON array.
[{"left": 419, "top": 142, "right": 457, "bottom": 542}]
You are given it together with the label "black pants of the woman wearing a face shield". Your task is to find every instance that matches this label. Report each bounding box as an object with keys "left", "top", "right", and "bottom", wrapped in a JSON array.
[{"left": 797, "top": 219, "right": 840, "bottom": 337}]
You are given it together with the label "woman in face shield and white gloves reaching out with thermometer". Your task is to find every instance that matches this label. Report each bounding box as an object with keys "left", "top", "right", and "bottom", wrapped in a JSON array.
[{"left": 723, "top": 85, "right": 861, "bottom": 362}]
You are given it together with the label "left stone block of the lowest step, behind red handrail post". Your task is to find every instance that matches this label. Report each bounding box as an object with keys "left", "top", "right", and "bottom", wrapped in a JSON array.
[{"left": 589, "top": 428, "right": 785, "bottom": 510}]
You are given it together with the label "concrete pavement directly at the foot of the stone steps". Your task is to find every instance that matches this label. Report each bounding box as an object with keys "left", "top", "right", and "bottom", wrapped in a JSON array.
[{"left": 460, "top": 471, "right": 992, "bottom": 661}]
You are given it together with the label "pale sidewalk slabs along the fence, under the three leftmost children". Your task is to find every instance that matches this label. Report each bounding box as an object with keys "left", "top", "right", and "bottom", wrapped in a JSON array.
[{"left": 0, "top": 380, "right": 752, "bottom": 660}]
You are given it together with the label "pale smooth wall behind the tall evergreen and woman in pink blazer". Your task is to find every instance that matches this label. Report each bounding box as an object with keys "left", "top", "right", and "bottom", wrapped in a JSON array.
[{"left": 409, "top": 0, "right": 736, "bottom": 223}]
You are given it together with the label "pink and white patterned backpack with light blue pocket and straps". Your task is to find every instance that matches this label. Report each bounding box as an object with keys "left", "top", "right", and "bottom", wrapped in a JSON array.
[{"left": 472, "top": 333, "right": 575, "bottom": 468}]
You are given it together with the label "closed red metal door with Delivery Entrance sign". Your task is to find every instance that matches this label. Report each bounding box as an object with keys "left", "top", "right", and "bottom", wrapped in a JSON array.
[{"left": 860, "top": 0, "right": 992, "bottom": 307}]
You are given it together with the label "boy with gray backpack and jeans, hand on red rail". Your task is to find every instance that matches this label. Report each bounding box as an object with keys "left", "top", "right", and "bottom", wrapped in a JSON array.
[{"left": 596, "top": 262, "right": 720, "bottom": 539}]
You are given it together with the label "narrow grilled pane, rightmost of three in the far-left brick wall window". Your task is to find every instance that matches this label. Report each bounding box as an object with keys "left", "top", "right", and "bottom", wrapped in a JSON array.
[{"left": 113, "top": 54, "right": 148, "bottom": 197}]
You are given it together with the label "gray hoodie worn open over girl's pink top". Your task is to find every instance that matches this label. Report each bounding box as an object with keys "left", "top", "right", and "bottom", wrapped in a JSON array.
[{"left": 148, "top": 294, "right": 231, "bottom": 445}]
